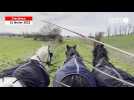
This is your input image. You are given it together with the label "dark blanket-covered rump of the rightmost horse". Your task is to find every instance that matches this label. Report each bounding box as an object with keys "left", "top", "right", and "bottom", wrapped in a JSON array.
[{"left": 93, "top": 65, "right": 127, "bottom": 87}]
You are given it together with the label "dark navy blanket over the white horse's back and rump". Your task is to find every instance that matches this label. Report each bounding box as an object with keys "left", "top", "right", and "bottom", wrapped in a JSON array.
[{"left": 13, "top": 60, "right": 50, "bottom": 87}]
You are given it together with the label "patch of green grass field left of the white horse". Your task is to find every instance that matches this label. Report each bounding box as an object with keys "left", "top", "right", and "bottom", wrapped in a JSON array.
[{"left": 0, "top": 37, "right": 43, "bottom": 70}]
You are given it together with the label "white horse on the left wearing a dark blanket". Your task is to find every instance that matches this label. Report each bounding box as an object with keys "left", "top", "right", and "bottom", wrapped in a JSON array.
[{"left": 0, "top": 47, "right": 52, "bottom": 87}]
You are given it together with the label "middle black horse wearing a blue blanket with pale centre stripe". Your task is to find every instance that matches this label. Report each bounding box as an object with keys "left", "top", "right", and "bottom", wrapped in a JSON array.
[{"left": 53, "top": 45, "right": 96, "bottom": 87}]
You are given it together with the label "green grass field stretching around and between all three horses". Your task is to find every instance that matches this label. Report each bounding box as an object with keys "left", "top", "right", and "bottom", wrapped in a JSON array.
[{"left": 0, "top": 36, "right": 134, "bottom": 86}]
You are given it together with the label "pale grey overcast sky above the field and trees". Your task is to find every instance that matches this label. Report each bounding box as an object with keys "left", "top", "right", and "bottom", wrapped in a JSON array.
[{"left": 0, "top": 12, "right": 134, "bottom": 35}]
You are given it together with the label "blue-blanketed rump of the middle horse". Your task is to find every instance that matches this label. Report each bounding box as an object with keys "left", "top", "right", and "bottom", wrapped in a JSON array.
[{"left": 53, "top": 62, "right": 96, "bottom": 87}]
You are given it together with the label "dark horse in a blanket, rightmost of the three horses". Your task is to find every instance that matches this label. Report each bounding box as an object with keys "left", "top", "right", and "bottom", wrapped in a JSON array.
[{"left": 93, "top": 44, "right": 134, "bottom": 87}]
